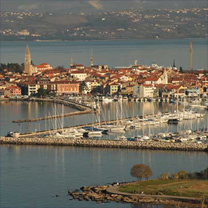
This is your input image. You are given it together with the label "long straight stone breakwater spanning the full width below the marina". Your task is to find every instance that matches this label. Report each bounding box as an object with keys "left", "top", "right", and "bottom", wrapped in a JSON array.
[{"left": 0, "top": 137, "right": 207, "bottom": 151}]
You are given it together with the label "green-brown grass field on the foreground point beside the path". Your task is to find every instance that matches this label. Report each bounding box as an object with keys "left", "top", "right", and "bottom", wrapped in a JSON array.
[{"left": 119, "top": 179, "right": 208, "bottom": 198}]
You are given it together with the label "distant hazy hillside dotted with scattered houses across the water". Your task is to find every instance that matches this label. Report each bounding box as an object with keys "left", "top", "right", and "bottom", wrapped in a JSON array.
[{"left": 0, "top": 7, "right": 208, "bottom": 41}]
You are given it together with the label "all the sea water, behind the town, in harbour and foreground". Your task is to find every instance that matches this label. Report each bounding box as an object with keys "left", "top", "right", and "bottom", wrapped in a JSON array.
[{"left": 0, "top": 39, "right": 208, "bottom": 208}]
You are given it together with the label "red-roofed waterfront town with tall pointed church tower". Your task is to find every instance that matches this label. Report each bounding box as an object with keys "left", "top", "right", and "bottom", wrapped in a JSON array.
[{"left": 0, "top": 42, "right": 208, "bottom": 101}]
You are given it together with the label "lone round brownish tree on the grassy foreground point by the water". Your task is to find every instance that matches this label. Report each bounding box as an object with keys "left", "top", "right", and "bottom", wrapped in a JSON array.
[{"left": 131, "top": 164, "right": 152, "bottom": 180}]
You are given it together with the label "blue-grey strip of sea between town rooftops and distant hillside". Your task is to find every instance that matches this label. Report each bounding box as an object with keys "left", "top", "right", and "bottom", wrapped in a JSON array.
[{"left": 0, "top": 39, "right": 208, "bottom": 69}]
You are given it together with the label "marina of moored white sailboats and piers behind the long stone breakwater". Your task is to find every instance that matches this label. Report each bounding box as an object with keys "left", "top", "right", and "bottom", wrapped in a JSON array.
[{"left": 2, "top": 96, "right": 208, "bottom": 149}]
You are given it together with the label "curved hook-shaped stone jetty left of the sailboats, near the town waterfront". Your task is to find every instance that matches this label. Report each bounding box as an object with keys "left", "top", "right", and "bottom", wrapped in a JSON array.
[{"left": 12, "top": 98, "right": 92, "bottom": 123}]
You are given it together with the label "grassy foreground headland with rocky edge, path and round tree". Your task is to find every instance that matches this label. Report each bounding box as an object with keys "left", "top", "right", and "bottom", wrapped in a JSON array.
[{"left": 68, "top": 164, "right": 208, "bottom": 208}]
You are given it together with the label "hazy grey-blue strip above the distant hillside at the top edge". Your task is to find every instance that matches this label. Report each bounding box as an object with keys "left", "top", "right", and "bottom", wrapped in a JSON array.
[{"left": 0, "top": 0, "right": 208, "bottom": 13}]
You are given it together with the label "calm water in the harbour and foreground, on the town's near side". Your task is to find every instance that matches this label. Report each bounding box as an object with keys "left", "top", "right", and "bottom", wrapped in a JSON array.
[{"left": 0, "top": 102, "right": 208, "bottom": 208}]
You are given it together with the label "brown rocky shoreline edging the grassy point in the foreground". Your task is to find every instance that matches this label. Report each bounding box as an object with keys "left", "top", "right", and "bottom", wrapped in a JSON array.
[{"left": 68, "top": 183, "right": 205, "bottom": 208}]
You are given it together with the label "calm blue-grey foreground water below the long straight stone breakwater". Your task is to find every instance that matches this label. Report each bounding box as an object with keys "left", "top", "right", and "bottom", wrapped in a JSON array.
[{"left": 0, "top": 145, "right": 208, "bottom": 208}]
